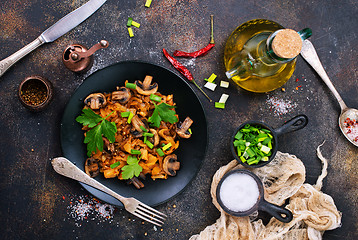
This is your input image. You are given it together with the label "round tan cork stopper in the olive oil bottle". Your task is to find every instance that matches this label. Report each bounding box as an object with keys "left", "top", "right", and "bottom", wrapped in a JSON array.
[{"left": 272, "top": 29, "right": 302, "bottom": 58}]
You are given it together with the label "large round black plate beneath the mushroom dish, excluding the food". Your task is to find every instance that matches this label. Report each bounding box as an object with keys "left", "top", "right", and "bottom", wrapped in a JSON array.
[{"left": 61, "top": 61, "right": 208, "bottom": 206}]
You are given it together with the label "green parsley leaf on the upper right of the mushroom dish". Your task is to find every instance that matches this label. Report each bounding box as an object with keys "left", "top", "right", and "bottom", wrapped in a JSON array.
[{"left": 148, "top": 103, "right": 178, "bottom": 127}]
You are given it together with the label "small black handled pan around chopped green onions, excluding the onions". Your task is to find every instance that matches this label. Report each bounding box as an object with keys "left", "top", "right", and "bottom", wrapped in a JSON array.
[{"left": 230, "top": 114, "right": 308, "bottom": 168}]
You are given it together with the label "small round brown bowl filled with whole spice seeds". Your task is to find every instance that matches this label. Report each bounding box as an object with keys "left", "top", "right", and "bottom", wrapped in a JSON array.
[{"left": 18, "top": 75, "right": 53, "bottom": 111}]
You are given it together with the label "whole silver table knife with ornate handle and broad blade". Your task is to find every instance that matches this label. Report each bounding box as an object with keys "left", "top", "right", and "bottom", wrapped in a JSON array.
[{"left": 0, "top": 0, "right": 107, "bottom": 77}]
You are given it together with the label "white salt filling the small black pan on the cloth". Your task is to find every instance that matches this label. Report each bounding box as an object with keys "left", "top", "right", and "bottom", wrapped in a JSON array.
[{"left": 219, "top": 173, "right": 260, "bottom": 212}]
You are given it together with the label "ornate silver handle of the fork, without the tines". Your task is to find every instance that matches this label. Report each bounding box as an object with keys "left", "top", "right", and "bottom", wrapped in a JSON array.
[{"left": 51, "top": 157, "right": 127, "bottom": 205}]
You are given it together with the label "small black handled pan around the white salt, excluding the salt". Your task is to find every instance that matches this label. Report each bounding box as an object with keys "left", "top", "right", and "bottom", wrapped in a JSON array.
[{"left": 216, "top": 169, "right": 293, "bottom": 223}]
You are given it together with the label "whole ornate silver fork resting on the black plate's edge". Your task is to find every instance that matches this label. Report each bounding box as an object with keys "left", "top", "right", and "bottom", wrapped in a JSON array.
[{"left": 51, "top": 157, "right": 167, "bottom": 226}]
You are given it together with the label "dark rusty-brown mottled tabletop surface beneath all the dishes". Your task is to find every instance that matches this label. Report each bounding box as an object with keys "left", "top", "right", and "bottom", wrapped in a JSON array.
[{"left": 0, "top": 0, "right": 358, "bottom": 239}]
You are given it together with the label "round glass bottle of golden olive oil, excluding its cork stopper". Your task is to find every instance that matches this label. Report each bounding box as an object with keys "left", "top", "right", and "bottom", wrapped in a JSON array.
[{"left": 224, "top": 19, "right": 310, "bottom": 93}]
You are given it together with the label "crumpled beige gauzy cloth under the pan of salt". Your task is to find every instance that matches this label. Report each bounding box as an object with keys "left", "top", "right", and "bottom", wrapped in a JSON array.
[{"left": 190, "top": 143, "right": 342, "bottom": 240}]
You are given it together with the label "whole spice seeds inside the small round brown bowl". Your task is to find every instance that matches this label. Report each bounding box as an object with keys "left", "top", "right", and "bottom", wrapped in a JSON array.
[{"left": 20, "top": 79, "right": 47, "bottom": 106}]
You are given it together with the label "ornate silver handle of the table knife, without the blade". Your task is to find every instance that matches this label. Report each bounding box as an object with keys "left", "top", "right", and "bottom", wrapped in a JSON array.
[{"left": 0, "top": 36, "right": 45, "bottom": 77}]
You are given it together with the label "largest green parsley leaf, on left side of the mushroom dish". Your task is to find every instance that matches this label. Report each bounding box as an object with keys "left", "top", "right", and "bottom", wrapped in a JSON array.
[{"left": 76, "top": 109, "right": 117, "bottom": 157}]
